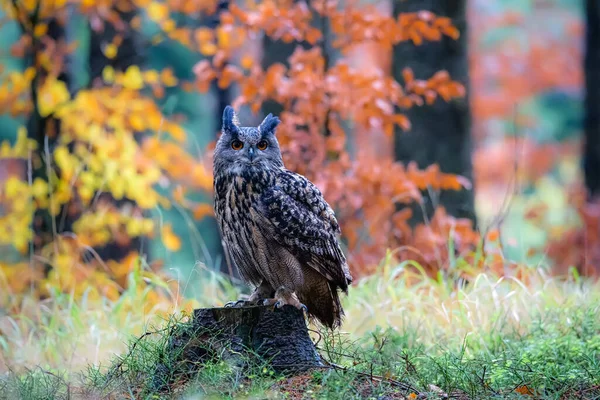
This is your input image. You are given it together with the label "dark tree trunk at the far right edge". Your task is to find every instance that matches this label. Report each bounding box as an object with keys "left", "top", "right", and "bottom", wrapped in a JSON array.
[{"left": 583, "top": 0, "right": 600, "bottom": 199}]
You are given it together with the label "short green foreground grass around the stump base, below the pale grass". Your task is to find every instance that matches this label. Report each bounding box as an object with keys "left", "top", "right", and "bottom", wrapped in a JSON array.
[{"left": 76, "top": 307, "right": 600, "bottom": 399}]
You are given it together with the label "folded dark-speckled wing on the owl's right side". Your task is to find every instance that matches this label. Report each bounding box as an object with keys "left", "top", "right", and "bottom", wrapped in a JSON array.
[{"left": 258, "top": 170, "right": 352, "bottom": 291}]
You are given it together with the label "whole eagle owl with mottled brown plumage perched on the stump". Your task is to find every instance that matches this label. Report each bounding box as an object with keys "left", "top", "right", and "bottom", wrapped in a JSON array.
[{"left": 214, "top": 106, "right": 352, "bottom": 328}]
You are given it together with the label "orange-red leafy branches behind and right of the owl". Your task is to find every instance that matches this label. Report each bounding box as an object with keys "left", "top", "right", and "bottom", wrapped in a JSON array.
[{"left": 185, "top": 1, "right": 478, "bottom": 276}]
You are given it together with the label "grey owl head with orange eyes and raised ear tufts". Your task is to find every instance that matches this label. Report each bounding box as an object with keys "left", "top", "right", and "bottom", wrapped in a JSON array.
[{"left": 214, "top": 106, "right": 283, "bottom": 174}]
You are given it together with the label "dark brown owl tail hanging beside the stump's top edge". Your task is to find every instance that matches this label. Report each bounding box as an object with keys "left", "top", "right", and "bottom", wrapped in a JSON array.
[{"left": 301, "top": 279, "right": 344, "bottom": 329}]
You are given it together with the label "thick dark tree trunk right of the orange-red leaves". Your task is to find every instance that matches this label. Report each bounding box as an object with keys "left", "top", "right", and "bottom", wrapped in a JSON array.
[{"left": 392, "top": 0, "right": 475, "bottom": 223}]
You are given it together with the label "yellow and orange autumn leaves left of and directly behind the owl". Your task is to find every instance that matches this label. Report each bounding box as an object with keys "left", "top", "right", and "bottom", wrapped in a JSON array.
[{"left": 0, "top": 0, "right": 592, "bottom": 314}]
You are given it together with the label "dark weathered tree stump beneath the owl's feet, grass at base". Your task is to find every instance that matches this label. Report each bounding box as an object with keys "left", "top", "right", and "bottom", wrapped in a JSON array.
[{"left": 154, "top": 305, "right": 323, "bottom": 389}]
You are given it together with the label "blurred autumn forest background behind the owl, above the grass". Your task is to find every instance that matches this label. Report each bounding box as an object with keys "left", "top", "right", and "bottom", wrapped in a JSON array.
[{"left": 0, "top": 0, "right": 600, "bottom": 309}]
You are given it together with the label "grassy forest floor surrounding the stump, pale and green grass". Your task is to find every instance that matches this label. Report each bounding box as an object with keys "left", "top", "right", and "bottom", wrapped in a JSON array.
[{"left": 0, "top": 265, "right": 600, "bottom": 400}]
